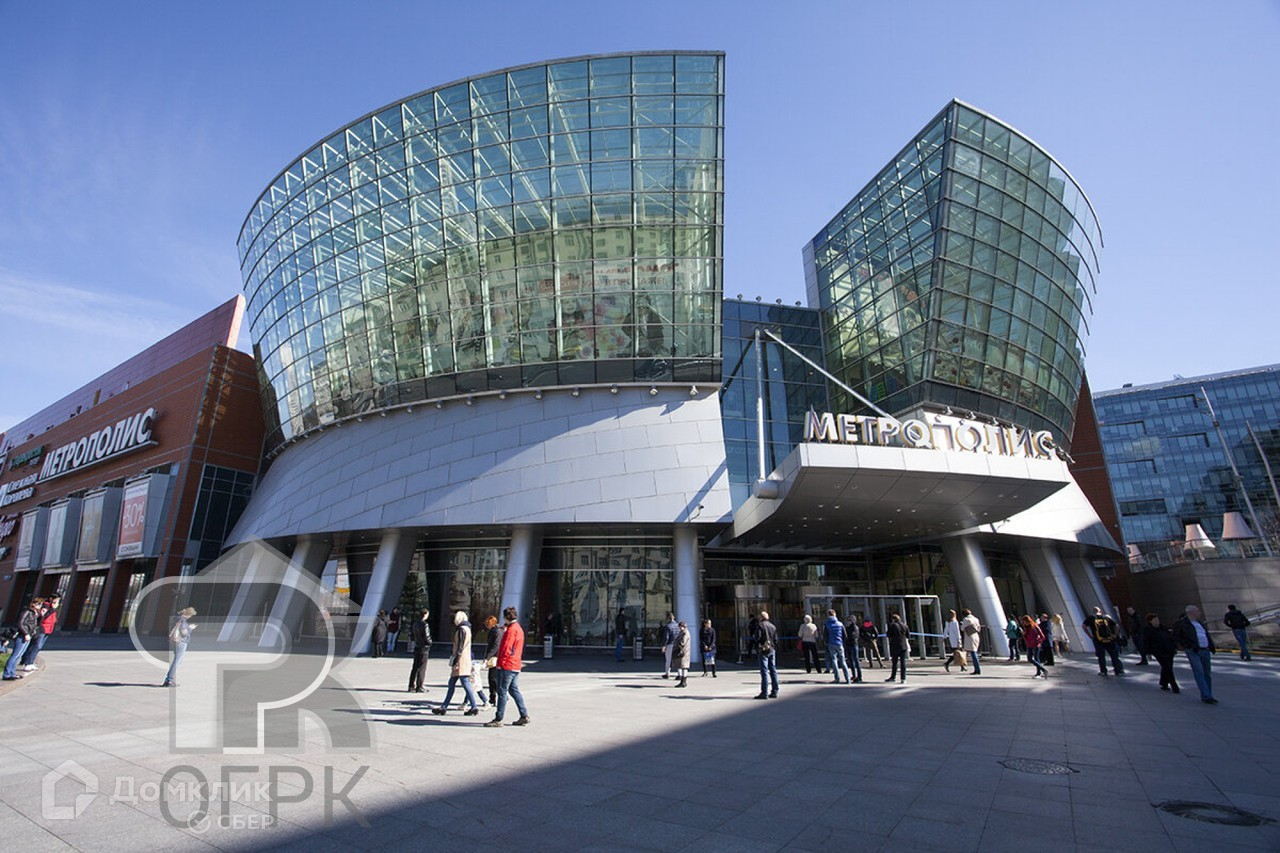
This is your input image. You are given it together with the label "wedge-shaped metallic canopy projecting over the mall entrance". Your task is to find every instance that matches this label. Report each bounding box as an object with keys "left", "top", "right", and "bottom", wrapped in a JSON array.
[{"left": 709, "top": 442, "right": 1071, "bottom": 551}]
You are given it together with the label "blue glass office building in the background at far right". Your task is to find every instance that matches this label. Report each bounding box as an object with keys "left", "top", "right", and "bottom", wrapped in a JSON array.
[{"left": 1093, "top": 365, "right": 1280, "bottom": 553}]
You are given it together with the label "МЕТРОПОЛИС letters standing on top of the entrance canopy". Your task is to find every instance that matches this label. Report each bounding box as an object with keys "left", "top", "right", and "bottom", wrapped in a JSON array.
[{"left": 804, "top": 409, "right": 1059, "bottom": 459}]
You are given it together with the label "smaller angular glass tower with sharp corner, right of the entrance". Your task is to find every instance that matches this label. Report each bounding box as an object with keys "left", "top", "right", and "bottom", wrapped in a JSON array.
[{"left": 805, "top": 101, "right": 1102, "bottom": 442}]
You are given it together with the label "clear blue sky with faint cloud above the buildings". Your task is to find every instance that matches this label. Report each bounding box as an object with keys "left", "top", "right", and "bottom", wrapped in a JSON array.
[{"left": 0, "top": 0, "right": 1280, "bottom": 430}]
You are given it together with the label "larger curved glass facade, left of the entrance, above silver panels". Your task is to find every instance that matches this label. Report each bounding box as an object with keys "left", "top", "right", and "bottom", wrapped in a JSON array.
[{"left": 238, "top": 53, "right": 723, "bottom": 446}]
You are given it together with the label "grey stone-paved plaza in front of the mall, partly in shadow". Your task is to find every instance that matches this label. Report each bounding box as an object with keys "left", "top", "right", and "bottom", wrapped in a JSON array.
[{"left": 0, "top": 637, "right": 1280, "bottom": 853}]
